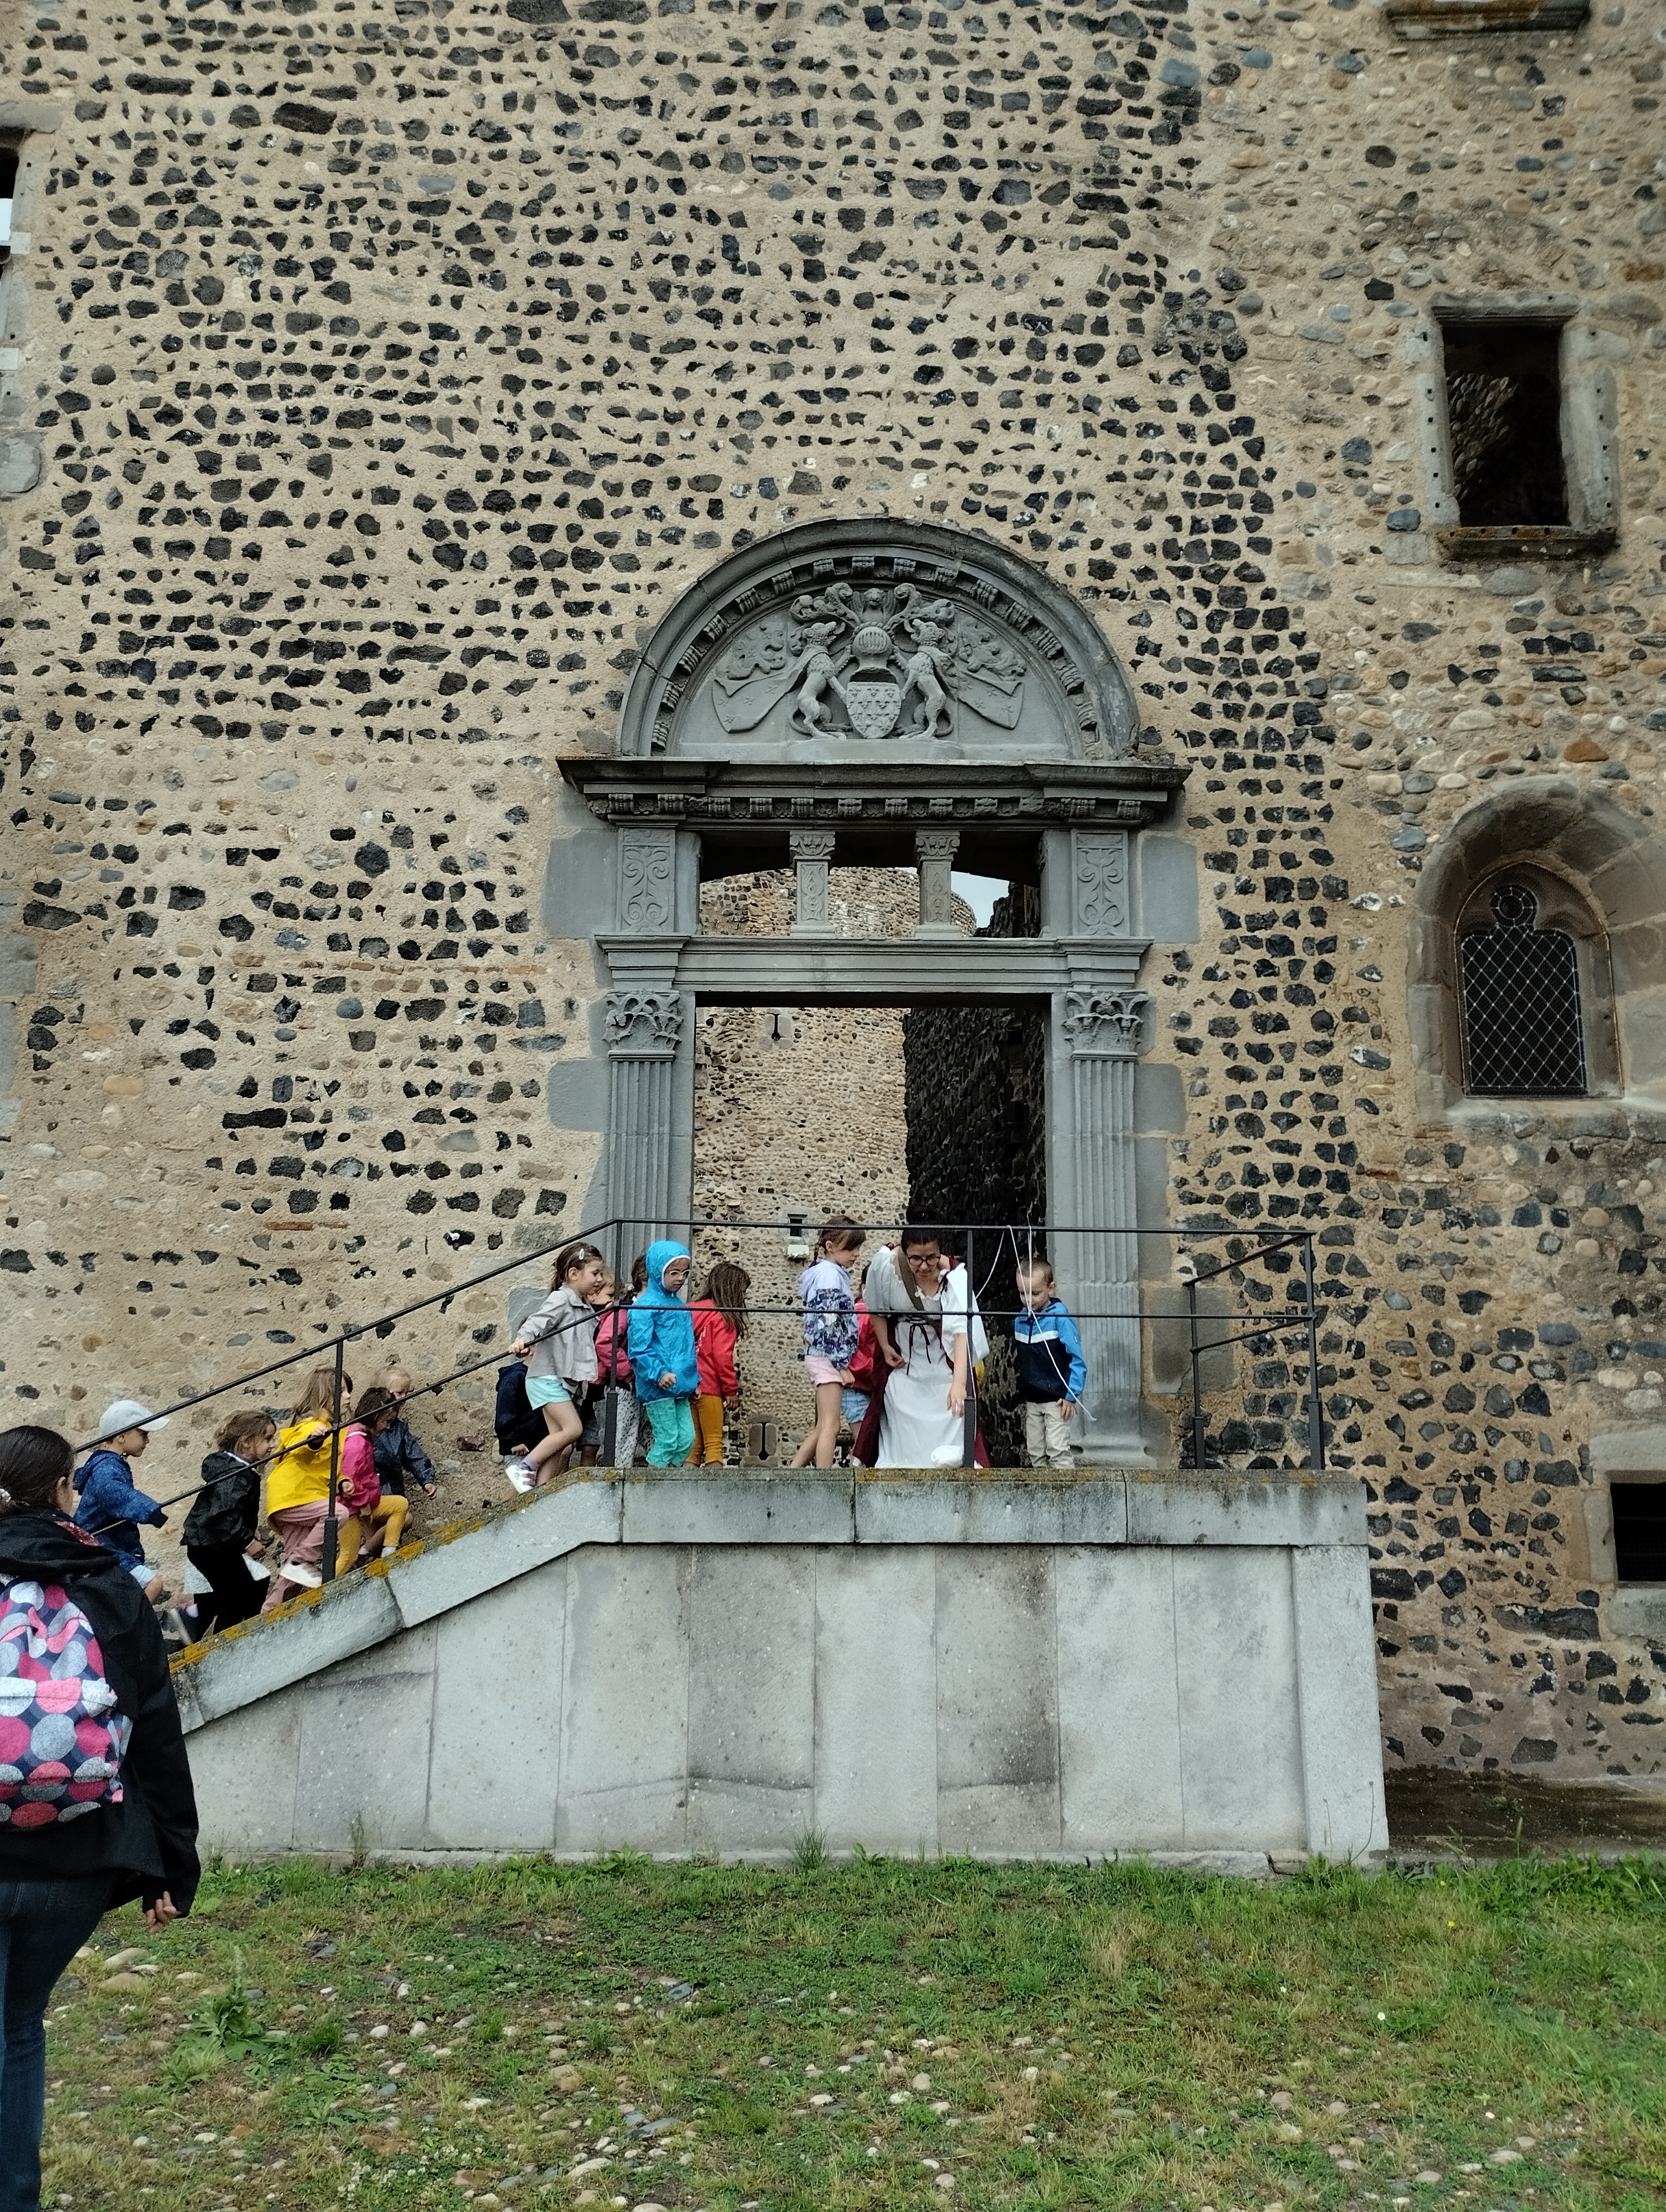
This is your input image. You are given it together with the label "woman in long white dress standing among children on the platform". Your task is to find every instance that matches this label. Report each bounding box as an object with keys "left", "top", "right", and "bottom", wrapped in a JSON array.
[{"left": 863, "top": 1227, "right": 989, "bottom": 1467}]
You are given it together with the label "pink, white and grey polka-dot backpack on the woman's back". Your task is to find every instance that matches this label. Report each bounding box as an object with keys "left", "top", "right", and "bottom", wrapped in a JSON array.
[{"left": 0, "top": 1575, "right": 133, "bottom": 1827}]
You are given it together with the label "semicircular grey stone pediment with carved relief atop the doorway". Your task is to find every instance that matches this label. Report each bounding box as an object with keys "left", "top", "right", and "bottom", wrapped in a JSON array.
[{"left": 617, "top": 520, "right": 1135, "bottom": 768}]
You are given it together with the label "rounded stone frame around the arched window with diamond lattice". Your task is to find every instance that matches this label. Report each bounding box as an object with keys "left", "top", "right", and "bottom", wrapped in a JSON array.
[{"left": 1407, "top": 774, "right": 1666, "bottom": 1133}]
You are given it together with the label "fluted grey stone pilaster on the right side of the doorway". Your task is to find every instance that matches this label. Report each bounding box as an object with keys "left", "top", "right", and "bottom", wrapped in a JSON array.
[{"left": 1047, "top": 987, "right": 1146, "bottom": 1464}]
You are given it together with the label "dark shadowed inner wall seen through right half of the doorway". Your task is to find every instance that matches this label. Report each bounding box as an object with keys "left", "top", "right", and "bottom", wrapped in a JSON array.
[{"left": 903, "top": 883, "right": 1047, "bottom": 1467}]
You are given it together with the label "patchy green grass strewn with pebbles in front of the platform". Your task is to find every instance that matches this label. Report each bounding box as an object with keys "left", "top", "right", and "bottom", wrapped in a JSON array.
[{"left": 35, "top": 1841, "right": 1666, "bottom": 2212}]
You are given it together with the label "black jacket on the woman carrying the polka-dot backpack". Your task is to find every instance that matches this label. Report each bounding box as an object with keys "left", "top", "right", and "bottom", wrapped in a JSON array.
[{"left": 0, "top": 1511, "right": 201, "bottom": 1913}]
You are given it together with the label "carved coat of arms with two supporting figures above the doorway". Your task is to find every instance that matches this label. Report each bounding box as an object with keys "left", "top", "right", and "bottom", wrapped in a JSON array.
[{"left": 710, "top": 582, "right": 1027, "bottom": 741}]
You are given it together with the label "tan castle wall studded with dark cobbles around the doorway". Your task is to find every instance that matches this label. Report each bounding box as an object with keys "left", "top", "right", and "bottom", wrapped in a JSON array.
[{"left": 0, "top": 0, "right": 1666, "bottom": 1776}]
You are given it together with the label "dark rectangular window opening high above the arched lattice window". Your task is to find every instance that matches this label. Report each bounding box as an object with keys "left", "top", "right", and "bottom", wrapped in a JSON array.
[{"left": 1443, "top": 321, "right": 1568, "bottom": 529}]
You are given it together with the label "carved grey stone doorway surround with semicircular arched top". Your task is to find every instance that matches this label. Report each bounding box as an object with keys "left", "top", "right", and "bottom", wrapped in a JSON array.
[{"left": 560, "top": 522, "right": 1195, "bottom": 1464}]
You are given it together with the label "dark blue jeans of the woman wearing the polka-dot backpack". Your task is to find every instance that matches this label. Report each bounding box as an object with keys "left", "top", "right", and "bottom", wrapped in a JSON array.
[{"left": 0, "top": 1867, "right": 111, "bottom": 2212}]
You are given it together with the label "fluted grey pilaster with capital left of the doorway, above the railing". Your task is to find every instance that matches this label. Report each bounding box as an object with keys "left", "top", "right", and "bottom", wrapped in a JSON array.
[{"left": 604, "top": 987, "right": 693, "bottom": 1268}]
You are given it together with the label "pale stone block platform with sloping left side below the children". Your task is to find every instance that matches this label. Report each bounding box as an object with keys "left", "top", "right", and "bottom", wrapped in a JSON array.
[{"left": 175, "top": 1469, "right": 1387, "bottom": 1874}]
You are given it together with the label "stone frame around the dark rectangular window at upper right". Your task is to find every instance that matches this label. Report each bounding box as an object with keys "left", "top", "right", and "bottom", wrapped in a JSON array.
[{"left": 1407, "top": 290, "right": 1619, "bottom": 562}]
